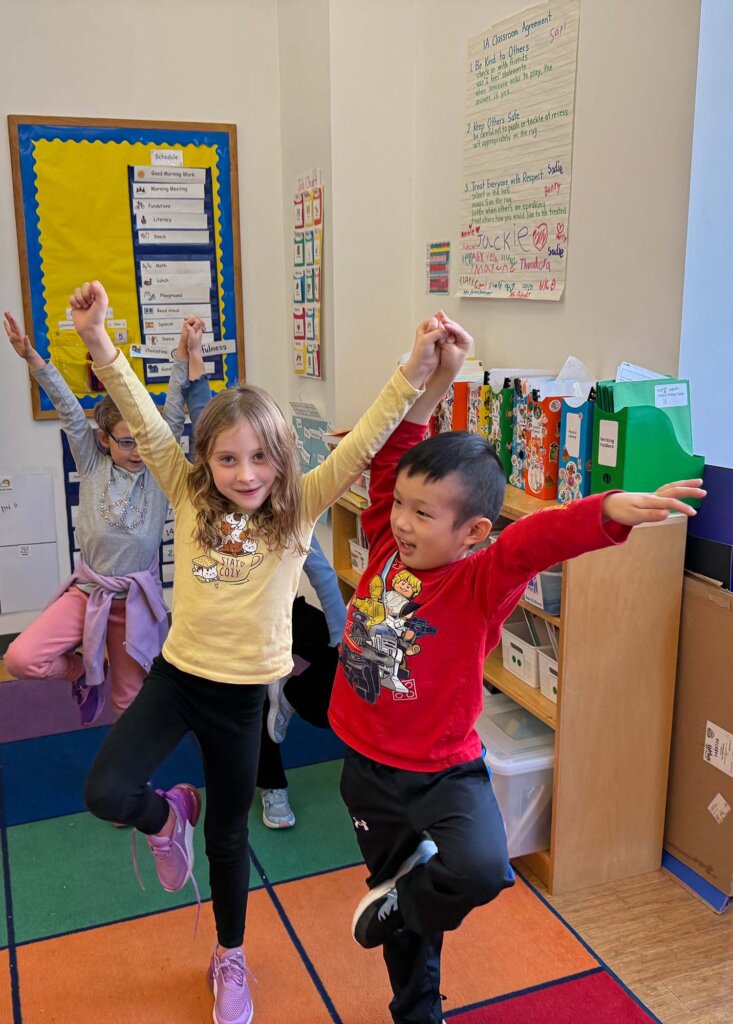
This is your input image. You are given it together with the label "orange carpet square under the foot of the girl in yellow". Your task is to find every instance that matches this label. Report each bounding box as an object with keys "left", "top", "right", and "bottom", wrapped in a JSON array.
[{"left": 17, "top": 890, "right": 331, "bottom": 1024}]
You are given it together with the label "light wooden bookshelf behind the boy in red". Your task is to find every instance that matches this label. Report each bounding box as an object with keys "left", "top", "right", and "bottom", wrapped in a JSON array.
[{"left": 333, "top": 487, "right": 687, "bottom": 893}]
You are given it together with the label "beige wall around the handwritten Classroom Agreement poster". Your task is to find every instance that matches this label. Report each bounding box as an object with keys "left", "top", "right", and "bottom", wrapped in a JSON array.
[{"left": 413, "top": 0, "right": 699, "bottom": 377}]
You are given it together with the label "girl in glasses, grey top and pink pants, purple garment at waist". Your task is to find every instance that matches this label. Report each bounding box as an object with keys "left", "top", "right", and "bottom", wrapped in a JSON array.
[{"left": 3, "top": 312, "right": 209, "bottom": 725}]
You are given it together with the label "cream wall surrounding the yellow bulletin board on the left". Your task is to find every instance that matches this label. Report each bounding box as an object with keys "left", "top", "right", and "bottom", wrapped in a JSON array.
[{"left": 0, "top": 0, "right": 287, "bottom": 633}]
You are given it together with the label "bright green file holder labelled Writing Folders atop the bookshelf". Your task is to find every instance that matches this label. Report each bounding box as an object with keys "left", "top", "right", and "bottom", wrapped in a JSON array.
[{"left": 591, "top": 406, "right": 705, "bottom": 499}]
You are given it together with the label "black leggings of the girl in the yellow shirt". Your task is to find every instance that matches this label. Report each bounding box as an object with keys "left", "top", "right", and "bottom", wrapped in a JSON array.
[{"left": 84, "top": 655, "right": 266, "bottom": 948}]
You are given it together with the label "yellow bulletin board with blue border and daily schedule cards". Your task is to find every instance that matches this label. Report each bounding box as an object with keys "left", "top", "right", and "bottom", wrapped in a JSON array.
[{"left": 8, "top": 115, "right": 245, "bottom": 419}]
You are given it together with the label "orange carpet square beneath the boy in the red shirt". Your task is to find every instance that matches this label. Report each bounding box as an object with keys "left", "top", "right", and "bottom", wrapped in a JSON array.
[{"left": 275, "top": 867, "right": 598, "bottom": 1024}]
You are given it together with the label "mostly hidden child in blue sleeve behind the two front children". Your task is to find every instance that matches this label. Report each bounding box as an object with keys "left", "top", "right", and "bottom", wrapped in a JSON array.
[{"left": 257, "top": 535, "right": 346, "bottom": 828}]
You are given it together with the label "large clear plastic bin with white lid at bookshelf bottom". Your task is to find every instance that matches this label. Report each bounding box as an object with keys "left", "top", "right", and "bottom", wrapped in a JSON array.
[{"left": 476, "top": 694, "right": 555, "bottom": 857}]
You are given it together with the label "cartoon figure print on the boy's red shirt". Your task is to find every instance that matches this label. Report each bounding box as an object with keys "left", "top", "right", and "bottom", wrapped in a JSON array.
[{"left": 340, "top": 554, "right": 437, "bottom": 703}]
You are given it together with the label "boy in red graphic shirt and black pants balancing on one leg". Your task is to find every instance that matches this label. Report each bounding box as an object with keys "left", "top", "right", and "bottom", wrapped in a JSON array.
[{"left": 330, "top": 313, "right": 704, "bottom": 1024}]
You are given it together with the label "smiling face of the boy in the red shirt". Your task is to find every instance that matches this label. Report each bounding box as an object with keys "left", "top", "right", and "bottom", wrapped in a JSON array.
[{"left": 390, "top": 471, "right": 491, "bottom": 573}]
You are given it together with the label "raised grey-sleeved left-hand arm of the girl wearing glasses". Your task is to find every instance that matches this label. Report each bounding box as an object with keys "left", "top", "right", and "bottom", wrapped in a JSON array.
[{"left": 3, "top": 312, "right": 101, "bottom": 474}]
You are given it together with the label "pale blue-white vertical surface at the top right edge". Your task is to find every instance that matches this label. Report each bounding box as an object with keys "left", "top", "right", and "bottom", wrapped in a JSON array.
[{"left": 680, "top": 0, "right": 733, "bottom": 469}]
